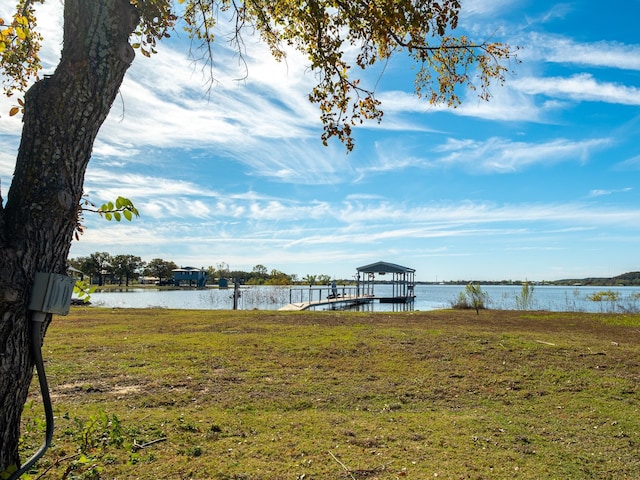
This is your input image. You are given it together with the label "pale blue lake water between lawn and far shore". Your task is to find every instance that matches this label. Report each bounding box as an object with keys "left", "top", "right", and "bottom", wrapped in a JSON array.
[{"left": 84, "top": 285, "right": 640, "bottom": 312}]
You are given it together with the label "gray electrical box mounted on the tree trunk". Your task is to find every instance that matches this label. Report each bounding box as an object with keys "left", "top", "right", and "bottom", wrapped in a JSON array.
[{"left": 29, "top": 272, "right": 76, "bottom": 315}]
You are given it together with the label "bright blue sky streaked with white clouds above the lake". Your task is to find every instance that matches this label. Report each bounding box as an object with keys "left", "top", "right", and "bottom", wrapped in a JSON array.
[{"left": 0, "top": 0, "right": 640, "bottom": 281}]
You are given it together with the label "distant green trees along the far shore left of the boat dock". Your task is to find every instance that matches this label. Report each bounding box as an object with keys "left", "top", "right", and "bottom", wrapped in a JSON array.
[{"left": 68, "top": 252, "right": 344, "bottom": 287}]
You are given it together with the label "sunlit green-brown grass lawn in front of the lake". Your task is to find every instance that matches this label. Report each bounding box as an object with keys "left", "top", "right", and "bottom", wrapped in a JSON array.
[{"left": 22, "top": 307, "right": 640, "bottom": 480}]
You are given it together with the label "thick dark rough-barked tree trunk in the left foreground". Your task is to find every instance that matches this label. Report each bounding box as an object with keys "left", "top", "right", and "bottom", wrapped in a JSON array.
[{"left": 0, "top": 0, "right": 138, "bottom": 473}]
